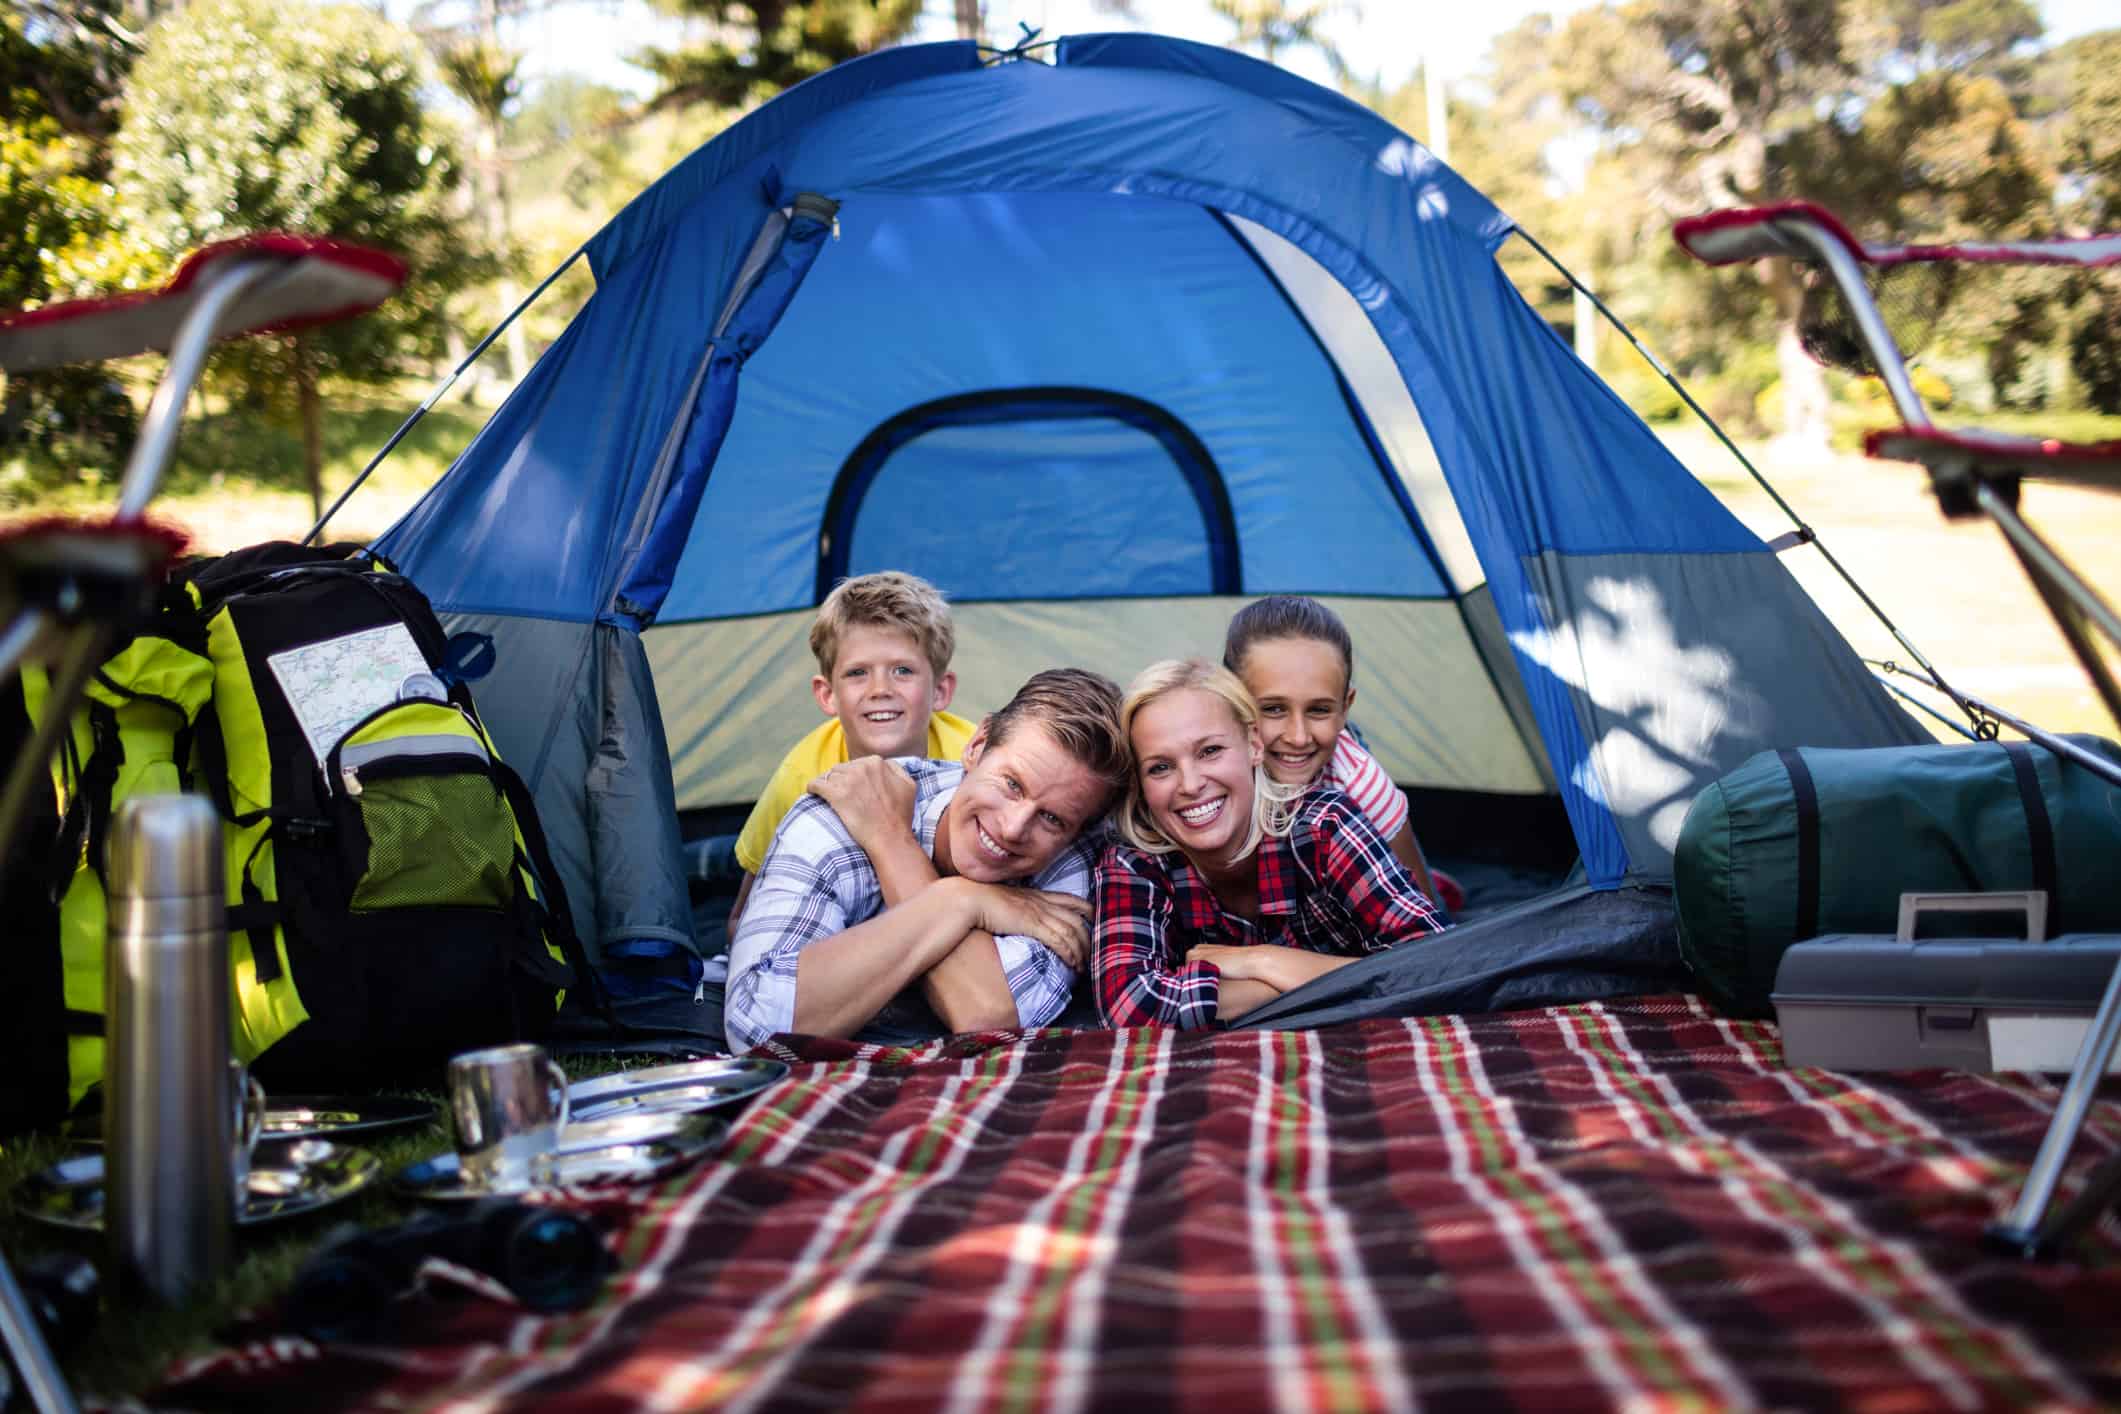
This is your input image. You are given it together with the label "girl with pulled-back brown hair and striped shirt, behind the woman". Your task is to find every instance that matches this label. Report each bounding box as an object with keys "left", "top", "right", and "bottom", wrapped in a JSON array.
[{"left": 1222, "top": 594, "right": 1466, "bottom": 912}]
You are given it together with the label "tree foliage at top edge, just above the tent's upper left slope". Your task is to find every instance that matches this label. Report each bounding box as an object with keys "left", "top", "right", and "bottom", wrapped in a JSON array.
[{"left": 636, "top": 0, "right": 921, "bottom": 110}]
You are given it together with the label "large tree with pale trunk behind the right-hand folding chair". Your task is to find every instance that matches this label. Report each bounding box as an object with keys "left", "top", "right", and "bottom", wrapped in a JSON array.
[{"left": 1555, "top": 0, "right": 2051, "bottom": 445}]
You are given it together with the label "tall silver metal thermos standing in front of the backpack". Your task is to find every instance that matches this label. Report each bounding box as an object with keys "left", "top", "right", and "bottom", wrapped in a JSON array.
[{"left": 104, "top": 795, "right": 238, "bottom": 1302}]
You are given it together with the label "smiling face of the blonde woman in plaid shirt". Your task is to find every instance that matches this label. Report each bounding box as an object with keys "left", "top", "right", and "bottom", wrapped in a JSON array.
[{"left": 1128, "top": 687, "right": 1262, "bottom": 863}]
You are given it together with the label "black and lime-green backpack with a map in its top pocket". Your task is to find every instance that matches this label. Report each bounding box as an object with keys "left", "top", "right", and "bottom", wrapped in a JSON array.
[{"left": 0, "top": 545, "right": 585, "bottom": 1128}]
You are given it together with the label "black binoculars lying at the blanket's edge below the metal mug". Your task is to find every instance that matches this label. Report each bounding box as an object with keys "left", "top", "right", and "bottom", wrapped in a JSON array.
[{"left": 284, "top": 1198, "right": 615, "bottom": 1340}]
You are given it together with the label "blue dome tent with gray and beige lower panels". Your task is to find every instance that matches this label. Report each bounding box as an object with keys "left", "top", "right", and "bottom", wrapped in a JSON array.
[{"left": 380, "top": 34, "right": 1928, "bottom": 966}]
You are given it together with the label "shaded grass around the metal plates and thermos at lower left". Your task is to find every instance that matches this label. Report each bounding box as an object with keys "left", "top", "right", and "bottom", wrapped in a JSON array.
[{"left": 0, "top": 1056, "right": 668, "bottom": 1408}]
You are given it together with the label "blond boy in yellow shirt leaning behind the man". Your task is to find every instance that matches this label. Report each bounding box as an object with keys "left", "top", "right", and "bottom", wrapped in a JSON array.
[{"left": 730, "top": 570, "right": 974, "bottom": 939}]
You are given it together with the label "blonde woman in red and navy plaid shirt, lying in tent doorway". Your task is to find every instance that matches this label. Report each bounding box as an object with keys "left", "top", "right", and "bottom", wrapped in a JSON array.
[{"left": 1092, "top": 659, "right": 1442, "bottom": 1028}]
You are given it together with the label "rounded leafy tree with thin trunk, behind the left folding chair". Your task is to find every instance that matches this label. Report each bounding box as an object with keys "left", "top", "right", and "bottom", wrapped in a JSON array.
[{"left": 112, "top": 0, "right": 484, "bottom": 519}]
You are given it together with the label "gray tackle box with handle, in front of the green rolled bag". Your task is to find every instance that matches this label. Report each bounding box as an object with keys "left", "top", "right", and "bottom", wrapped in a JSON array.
[{"left": 1773, "top": 894, "right": 2121, "bottom": 1071}]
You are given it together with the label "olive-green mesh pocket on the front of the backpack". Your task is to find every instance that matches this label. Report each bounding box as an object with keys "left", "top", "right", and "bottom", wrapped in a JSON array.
[{"left": 352, "top": 772, "right": 515, "bottom": 912}]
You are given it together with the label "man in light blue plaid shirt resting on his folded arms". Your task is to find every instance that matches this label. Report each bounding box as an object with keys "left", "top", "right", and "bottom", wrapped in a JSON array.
[{"left": 725, "top": 668, "right": 1128, "bottom": 1051}]
